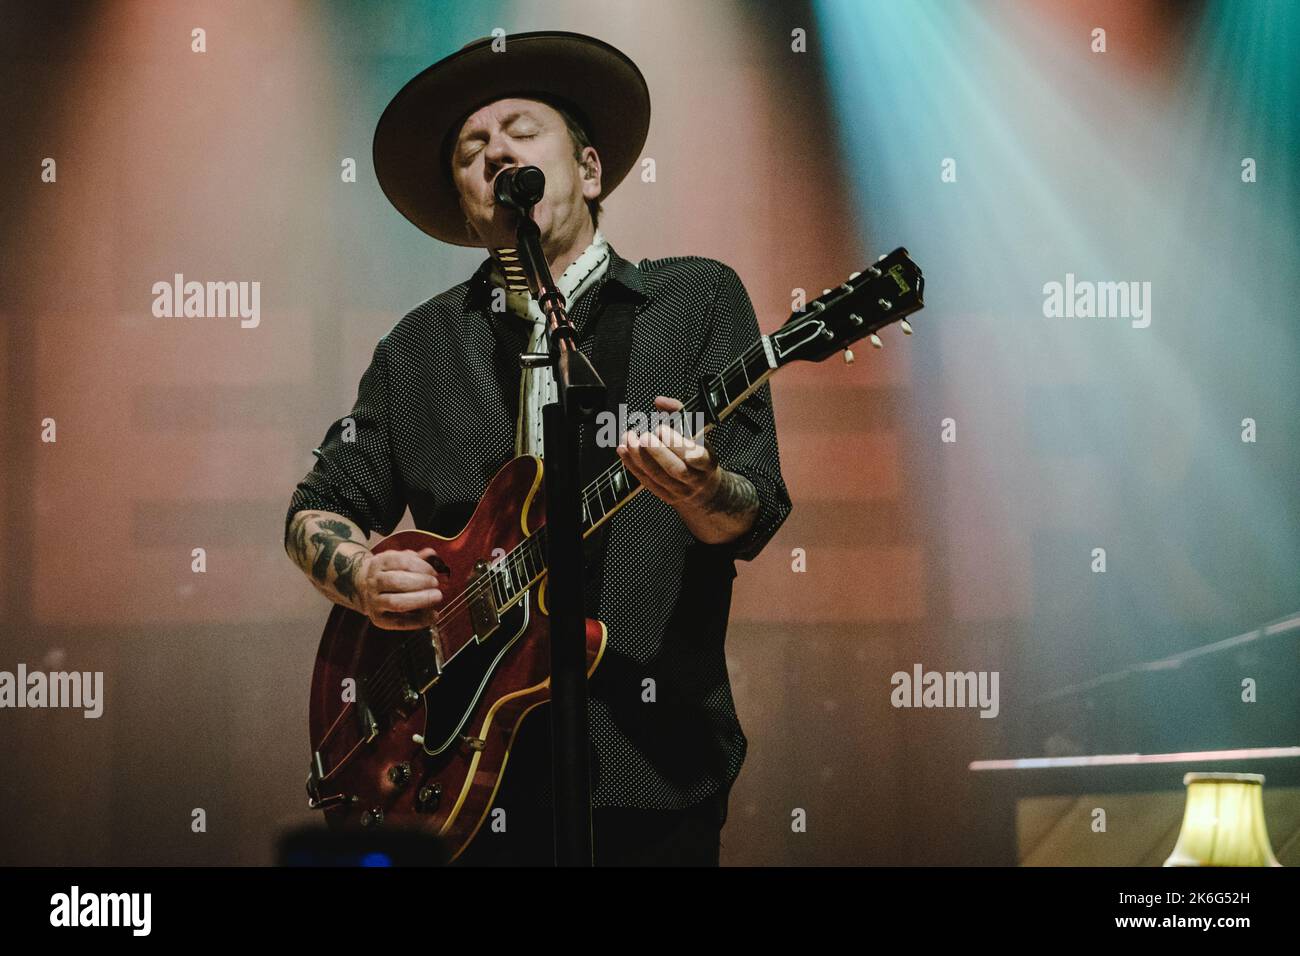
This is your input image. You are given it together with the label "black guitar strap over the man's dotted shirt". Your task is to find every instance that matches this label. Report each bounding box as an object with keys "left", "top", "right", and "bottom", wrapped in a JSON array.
[{"left": 579, "top": 282, "right": 637, "bottom": 618}]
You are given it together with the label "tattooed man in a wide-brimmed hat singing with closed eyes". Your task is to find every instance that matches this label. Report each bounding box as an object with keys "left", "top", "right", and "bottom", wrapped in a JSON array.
[{"left": 285, "top": 33, "right": 790, "bottom": 865}]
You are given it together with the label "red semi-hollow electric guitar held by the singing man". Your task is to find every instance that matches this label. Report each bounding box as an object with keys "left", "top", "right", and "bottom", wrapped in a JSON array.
[{"left": 307, "top": 248, "right": 924, "bottom": 858}]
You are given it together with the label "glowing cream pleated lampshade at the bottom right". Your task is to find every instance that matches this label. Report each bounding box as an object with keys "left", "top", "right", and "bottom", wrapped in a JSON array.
[{"left": 1165, "top": 774, "right": 1282, "bottom": 866}]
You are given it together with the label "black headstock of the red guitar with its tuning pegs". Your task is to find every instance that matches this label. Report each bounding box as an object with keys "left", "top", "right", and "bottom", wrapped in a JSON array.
[{"left": 768, "top": 246, "right": 926, "bottom": 365}]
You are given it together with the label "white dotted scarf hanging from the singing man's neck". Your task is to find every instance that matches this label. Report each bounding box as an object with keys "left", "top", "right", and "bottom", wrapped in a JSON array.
[{"left": 489, "top": 229, "right": 610, "bottom": 458}]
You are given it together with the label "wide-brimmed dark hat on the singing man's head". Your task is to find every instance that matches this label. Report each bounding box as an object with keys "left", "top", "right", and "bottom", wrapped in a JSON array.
[{"left": 374, "top": 31, "right": 650, "bottom": 246}]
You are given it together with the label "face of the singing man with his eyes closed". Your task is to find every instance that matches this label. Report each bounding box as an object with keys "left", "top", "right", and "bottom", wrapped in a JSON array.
[{"left": 451, "top": 99, "right": 601, "bottom": 248}]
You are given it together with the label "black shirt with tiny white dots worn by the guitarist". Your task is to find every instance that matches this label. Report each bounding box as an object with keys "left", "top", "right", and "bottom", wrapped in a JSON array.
[{"left": 285, "top": 247, "right": 790, "bottom": 809}]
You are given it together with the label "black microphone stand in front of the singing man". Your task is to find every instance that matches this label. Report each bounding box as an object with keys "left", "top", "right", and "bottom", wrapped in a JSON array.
[{"left": 516, "top": 195, "right": 605, "bottom": 866}]
